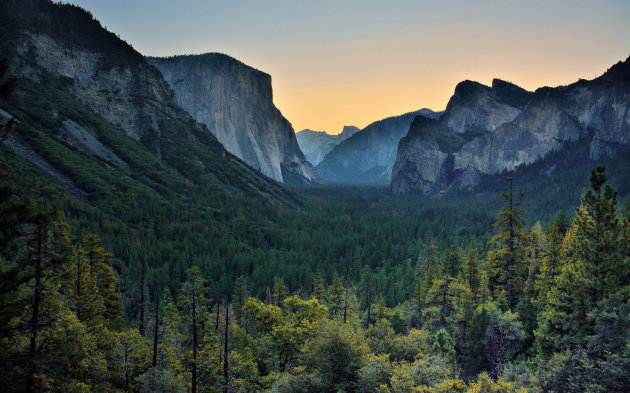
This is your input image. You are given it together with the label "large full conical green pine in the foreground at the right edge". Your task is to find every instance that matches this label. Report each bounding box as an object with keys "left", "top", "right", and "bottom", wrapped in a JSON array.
[{"left": 536, "top": 166, "right": 630, "bottom": 355}]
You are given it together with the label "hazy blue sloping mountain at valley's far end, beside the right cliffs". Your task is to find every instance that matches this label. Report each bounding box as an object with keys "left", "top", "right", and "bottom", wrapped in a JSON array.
[{"left": 316, "top": 109, "right": 439, "bottom": 185}]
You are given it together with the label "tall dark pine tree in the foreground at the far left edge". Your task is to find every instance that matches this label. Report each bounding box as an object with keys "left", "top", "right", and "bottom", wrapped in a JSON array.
[{"left": 0, "top": 187, "right": 71, "bottom": 392}]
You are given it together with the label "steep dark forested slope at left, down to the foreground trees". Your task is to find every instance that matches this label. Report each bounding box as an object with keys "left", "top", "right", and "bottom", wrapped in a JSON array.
[{"left": 0, "top": 0, "right": 314, "bottom": 298}]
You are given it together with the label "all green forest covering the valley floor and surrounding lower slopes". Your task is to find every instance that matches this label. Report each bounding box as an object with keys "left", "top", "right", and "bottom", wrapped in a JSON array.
[{"left": 0, "top": 0, "right": 630, "bottom": 393}]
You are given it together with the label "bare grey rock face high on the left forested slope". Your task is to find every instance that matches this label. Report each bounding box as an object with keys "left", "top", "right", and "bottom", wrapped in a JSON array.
[{"left": 11, "top": 31, "right": 186, "bottom": 145}]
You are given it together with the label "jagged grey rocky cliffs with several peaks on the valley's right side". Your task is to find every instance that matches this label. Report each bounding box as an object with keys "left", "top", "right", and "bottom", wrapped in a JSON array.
[{"left": 391, "top": 58, "right": 630, "bottom": 194}]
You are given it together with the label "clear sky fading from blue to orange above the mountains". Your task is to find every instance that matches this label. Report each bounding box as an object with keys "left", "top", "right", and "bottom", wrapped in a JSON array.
[{"left": 61, "top": 0, "right": 630, "bottom": 134}]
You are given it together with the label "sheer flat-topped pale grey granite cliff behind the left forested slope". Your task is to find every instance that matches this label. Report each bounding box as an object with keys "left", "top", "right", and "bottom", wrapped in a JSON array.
[{"left": 147, "top": 53, "right": 320, "bottom": 185}]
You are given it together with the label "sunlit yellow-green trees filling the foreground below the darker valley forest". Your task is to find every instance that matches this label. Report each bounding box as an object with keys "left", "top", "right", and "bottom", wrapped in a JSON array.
[{"left": 0, "top": 166, "right": 630, "bottom": 392}]
